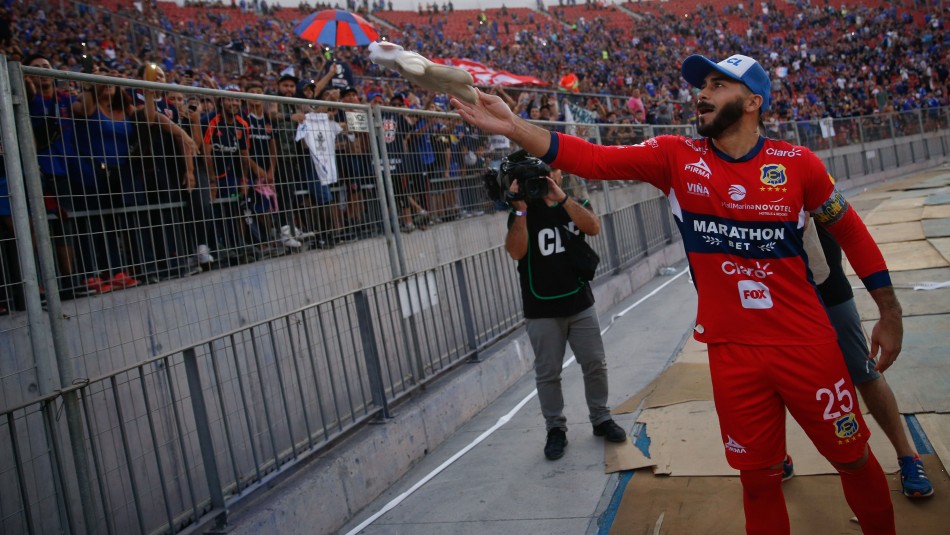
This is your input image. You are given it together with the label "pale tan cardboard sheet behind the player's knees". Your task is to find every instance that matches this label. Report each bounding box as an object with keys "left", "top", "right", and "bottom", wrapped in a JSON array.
[{"left": 637, "top": 401, "right": 898, "bottom": 476}]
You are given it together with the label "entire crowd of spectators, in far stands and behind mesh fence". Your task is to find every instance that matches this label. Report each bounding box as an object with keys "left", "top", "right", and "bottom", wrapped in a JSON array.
[{"left": 0, "top": 0, "right": 950, "bottom": 313}]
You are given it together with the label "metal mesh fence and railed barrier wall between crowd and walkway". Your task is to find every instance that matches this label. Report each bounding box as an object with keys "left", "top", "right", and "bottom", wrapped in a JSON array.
[{"left": 0, "top": 56, "right": 950, "bottom": 533}]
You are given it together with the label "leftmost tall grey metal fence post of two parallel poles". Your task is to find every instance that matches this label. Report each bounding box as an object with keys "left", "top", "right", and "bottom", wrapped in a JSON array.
[{"left": 0, "top": 57, "right": 98, "bottom": 533}]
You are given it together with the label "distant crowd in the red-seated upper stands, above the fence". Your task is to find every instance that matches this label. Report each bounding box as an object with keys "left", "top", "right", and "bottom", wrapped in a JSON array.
[{"left": 3, "top": 0, "right": 950, "bottom": 123}]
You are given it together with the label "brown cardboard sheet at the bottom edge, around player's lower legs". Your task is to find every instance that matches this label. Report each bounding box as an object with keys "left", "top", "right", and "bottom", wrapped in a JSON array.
[{"left": 610, "top": 455, "right": 950, "bottom": 535}]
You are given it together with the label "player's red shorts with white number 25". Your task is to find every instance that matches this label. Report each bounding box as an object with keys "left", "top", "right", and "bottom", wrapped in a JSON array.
[{"left": 708, "top": 342, "right": 870, "bottom": 470}]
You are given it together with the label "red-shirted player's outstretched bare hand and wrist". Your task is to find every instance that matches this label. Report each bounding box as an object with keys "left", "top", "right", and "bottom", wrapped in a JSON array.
[{"left": 451, "top": 89, "right": 551, "bottom": 157}]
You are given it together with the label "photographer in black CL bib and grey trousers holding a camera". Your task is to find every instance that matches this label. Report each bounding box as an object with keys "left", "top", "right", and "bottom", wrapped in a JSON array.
[{"left": 499, "top": 152, "right": 627, "bottom": 461}]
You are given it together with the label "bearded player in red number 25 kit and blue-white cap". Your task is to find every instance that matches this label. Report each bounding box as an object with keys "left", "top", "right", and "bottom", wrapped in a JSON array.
[{"left": 452, "top": 54, "right": 903, "bottom": 534}]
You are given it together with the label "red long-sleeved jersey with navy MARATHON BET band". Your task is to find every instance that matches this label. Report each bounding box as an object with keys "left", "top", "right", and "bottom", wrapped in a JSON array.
[{"left": 544, "top": 133, "right": 890, "bottom": 345}]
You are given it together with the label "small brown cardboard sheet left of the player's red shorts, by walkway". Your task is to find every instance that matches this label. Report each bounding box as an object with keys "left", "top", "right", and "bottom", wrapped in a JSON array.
[{"left": 611, "top": 363, "right": 712, "bottom": 414}]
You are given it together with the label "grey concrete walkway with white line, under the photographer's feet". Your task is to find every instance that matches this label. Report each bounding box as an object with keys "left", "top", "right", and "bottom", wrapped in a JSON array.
[{"left": 340, "top": 168, "right": 950, "bottom": 535}]
